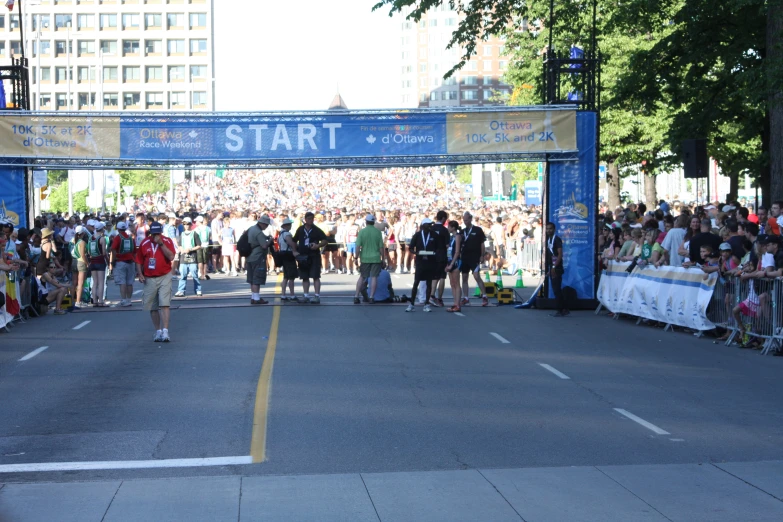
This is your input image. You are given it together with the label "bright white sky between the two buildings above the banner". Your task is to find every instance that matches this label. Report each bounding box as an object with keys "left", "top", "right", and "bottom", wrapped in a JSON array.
[{"left": 215, "top": 0, "right": 401, "bottom": 111}]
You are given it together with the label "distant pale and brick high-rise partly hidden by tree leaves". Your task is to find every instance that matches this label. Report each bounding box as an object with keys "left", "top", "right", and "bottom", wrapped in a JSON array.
[{"left": 400, "top": 5, "right": 511, "bottom": 107}]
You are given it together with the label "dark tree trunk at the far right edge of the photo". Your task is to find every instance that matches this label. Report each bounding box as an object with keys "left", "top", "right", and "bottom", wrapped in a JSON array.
[{"left": 762, "top": 0, "right": 783, "bottom": 203}]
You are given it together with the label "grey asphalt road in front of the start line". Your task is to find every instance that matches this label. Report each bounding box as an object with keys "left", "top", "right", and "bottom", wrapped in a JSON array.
[{"left": 0, "top": 275, "right": 783, "bottom": 482}]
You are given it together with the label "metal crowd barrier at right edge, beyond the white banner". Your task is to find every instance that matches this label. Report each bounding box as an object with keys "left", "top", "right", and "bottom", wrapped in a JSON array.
[{"left": 707, "top": 277, "right": 783, "bottom": 355}]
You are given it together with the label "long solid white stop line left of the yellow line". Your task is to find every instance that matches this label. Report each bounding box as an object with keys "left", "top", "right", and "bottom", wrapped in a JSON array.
[{"left": 0, "top": 456, "right": 253, "bottom": 473}]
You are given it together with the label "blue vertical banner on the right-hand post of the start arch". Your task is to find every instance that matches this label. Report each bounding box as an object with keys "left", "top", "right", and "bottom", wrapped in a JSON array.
[{"left": 548, "top": 112, "right": 597, "bottom": 299}]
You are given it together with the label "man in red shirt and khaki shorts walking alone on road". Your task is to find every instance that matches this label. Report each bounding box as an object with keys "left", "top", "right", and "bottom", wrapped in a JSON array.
[{"left": 136, "top": 221, "right": 176, "bottom": 343}]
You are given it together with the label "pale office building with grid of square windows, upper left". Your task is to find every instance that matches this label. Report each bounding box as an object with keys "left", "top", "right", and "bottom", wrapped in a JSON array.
[{"left": 0, "top": 0, "right": 214, "bottom": 111}]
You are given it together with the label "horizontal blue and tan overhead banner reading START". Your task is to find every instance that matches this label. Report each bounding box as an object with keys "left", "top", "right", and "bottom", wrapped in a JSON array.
[{"left": 0, "top": 109, "right": 577, "bottom": 162}]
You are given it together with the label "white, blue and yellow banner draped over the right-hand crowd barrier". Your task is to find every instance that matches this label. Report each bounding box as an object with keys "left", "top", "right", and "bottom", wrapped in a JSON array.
[{"left": 598, "top": 263, "right": 718, "bottom": 330}]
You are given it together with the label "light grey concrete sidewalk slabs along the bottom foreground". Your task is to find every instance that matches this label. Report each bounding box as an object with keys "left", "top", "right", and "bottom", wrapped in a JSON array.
[{"left": 0, "top": 461, "right": 783, "bottom": 522}]
